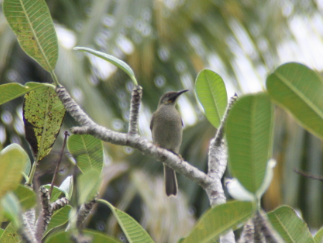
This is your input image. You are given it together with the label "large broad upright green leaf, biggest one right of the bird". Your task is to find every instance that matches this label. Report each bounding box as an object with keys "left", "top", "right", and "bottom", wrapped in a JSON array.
[{"left": 225, "top": 94, "right": 273, "bottom": 194}]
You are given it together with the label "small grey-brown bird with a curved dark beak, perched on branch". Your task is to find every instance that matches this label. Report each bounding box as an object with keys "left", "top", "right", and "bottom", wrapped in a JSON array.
[{"left": 150, "top": 89, "right": 188, "bottom": 196}]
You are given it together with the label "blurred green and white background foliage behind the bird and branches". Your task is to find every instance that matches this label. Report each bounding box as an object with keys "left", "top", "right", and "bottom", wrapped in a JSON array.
[{"left": 0, "top": 0, "right": 323, "bottom": 242}]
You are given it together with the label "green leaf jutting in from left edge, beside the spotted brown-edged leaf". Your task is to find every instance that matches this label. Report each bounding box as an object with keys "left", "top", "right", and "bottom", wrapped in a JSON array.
[{"left": 0, "top": 82, "right": 44, "bottom": 105}]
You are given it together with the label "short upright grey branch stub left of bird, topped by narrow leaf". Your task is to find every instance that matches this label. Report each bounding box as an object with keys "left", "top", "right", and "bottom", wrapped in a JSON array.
[{"left": 128, "top": 85, "right": 142, "bottom": 135}]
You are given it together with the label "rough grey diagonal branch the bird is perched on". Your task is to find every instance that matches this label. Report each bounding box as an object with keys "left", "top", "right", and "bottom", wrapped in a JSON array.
[{"left": 56, "top": 87, "right": 212, "bottom": 188}]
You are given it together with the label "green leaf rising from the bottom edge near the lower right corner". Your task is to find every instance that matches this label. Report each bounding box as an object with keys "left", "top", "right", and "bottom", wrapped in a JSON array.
[{"left": 268, "top": 206, "right": 314, "bottom": 243}]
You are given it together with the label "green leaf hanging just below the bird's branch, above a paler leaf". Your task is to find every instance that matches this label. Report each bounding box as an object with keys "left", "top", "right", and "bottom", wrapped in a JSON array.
[{"left": 67, "top": 134, "right": 103, "bottom": 173}]
